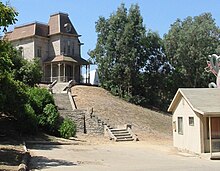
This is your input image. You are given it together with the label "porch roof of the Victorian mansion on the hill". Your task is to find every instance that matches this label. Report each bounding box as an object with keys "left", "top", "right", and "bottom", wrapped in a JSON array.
[{"left": 44, "top": 55, "right": 89, "bottom": 65}]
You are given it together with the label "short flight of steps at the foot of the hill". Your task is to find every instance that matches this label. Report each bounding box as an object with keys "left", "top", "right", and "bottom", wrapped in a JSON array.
[{"left": 109, "top": 128, "right": 134, "bottom": 142}]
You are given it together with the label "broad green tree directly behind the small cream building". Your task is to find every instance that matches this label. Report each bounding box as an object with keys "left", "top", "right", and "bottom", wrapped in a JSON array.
[{"left": 164, "top": 13, "right": 220, "bottom": 88}]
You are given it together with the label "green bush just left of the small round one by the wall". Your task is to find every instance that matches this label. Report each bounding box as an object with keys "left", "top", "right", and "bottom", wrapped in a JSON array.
[{"left": 38, "top": 104, "right": 59, "bottom": 133}]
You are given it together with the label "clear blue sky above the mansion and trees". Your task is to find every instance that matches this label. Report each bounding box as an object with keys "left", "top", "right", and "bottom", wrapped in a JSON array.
[{"left": 2, "top": 0, "right": 220, "bottom": 63}]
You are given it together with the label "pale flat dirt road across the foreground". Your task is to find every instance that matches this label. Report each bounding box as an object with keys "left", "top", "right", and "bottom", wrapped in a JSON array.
[{"left": 27, "top": 137, "right": 220, "bottom": 171}]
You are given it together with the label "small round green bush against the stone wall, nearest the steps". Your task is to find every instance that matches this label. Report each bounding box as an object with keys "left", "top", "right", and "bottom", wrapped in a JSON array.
[{"left": 59, "top": 118, "right": 76, "bottom": 138}]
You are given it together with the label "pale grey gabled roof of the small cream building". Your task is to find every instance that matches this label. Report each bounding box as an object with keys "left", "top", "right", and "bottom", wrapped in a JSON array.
[{"left": 168, "top": 88, "right": 220, "bottom": 116}]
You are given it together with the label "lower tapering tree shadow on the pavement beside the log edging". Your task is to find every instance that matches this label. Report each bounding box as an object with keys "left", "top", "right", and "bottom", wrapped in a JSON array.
[{"left": 29, "top": 156, "right": 77, "bottom": 170}]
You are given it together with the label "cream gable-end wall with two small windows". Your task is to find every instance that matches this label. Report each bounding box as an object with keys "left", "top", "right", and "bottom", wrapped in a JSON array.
[{"left": 173, "top": 98, "right": 202, "bottom": 153}]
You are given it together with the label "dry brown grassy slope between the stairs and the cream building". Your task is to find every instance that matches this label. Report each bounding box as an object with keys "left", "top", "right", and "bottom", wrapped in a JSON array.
[{"left": 72, "top": 86, "right": 172, "bottom": 140}]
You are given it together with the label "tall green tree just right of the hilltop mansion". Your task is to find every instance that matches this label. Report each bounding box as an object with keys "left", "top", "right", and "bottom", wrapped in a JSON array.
[{"left": 89, "top": 4, "right": 146, "bottom": 97}]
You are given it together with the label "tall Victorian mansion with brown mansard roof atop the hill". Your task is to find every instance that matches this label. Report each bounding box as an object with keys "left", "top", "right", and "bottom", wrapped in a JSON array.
[{"left": 4, "top": 12, "right": 89, "bottom": 82}]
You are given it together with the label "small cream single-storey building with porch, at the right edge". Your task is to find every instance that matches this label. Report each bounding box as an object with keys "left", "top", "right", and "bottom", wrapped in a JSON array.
[{"left": 168, "top": 88, "right": 220, "bottom": 155}]
